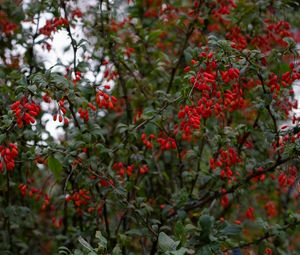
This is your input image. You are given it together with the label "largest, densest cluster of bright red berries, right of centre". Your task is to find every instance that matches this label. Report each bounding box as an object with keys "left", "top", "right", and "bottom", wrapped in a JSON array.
[{"left": 178, "top": 52, "right": 244, "bottom": 137}]
